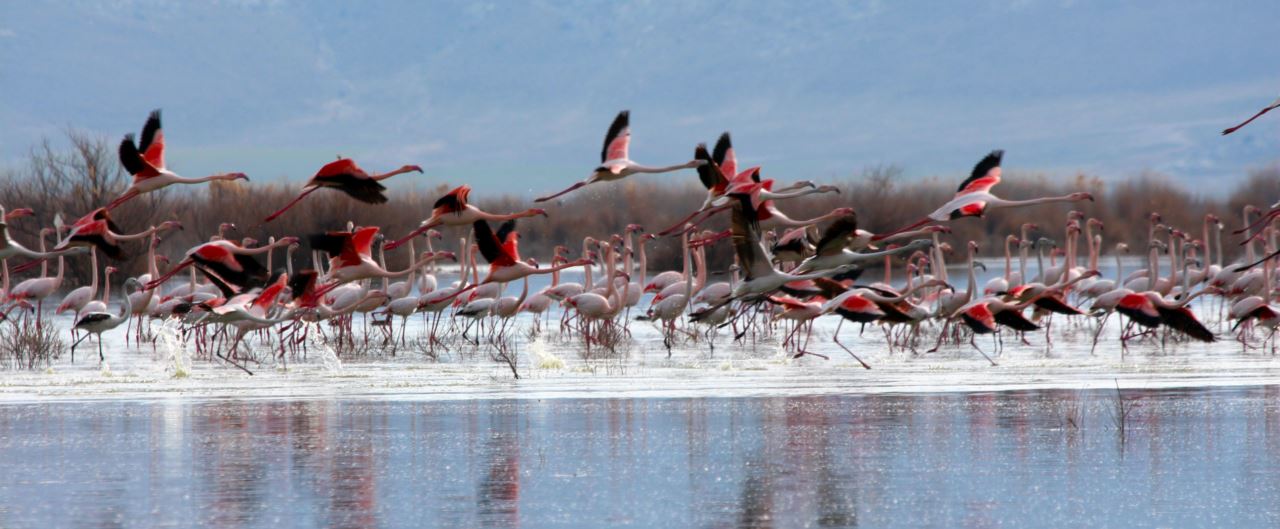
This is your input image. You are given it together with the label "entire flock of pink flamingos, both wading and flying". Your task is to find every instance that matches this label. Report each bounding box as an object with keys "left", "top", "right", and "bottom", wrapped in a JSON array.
[{"left": 0, "top": 100, "right": 1280, "bottom": 373}]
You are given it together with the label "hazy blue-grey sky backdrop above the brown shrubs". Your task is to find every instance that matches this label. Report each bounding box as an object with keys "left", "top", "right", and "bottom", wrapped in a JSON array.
[{"left": 0, "top": 0, "right": 1280, "bottom": 192}]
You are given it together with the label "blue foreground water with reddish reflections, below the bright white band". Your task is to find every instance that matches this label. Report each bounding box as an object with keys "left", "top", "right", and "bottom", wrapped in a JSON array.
[{"left": 0, "top": 387, "right": 1280, "bottom": 528}]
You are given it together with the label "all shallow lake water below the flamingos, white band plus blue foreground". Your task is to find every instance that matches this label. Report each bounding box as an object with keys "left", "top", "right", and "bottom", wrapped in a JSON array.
[{"left": 0, "top": 258, "right": 1280, "bottom": 528}]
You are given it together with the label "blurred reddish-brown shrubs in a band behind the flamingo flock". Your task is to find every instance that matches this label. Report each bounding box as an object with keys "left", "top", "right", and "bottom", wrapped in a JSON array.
[{"left": 0, "top": 132, "right": 1280, "bottom": 284}]
